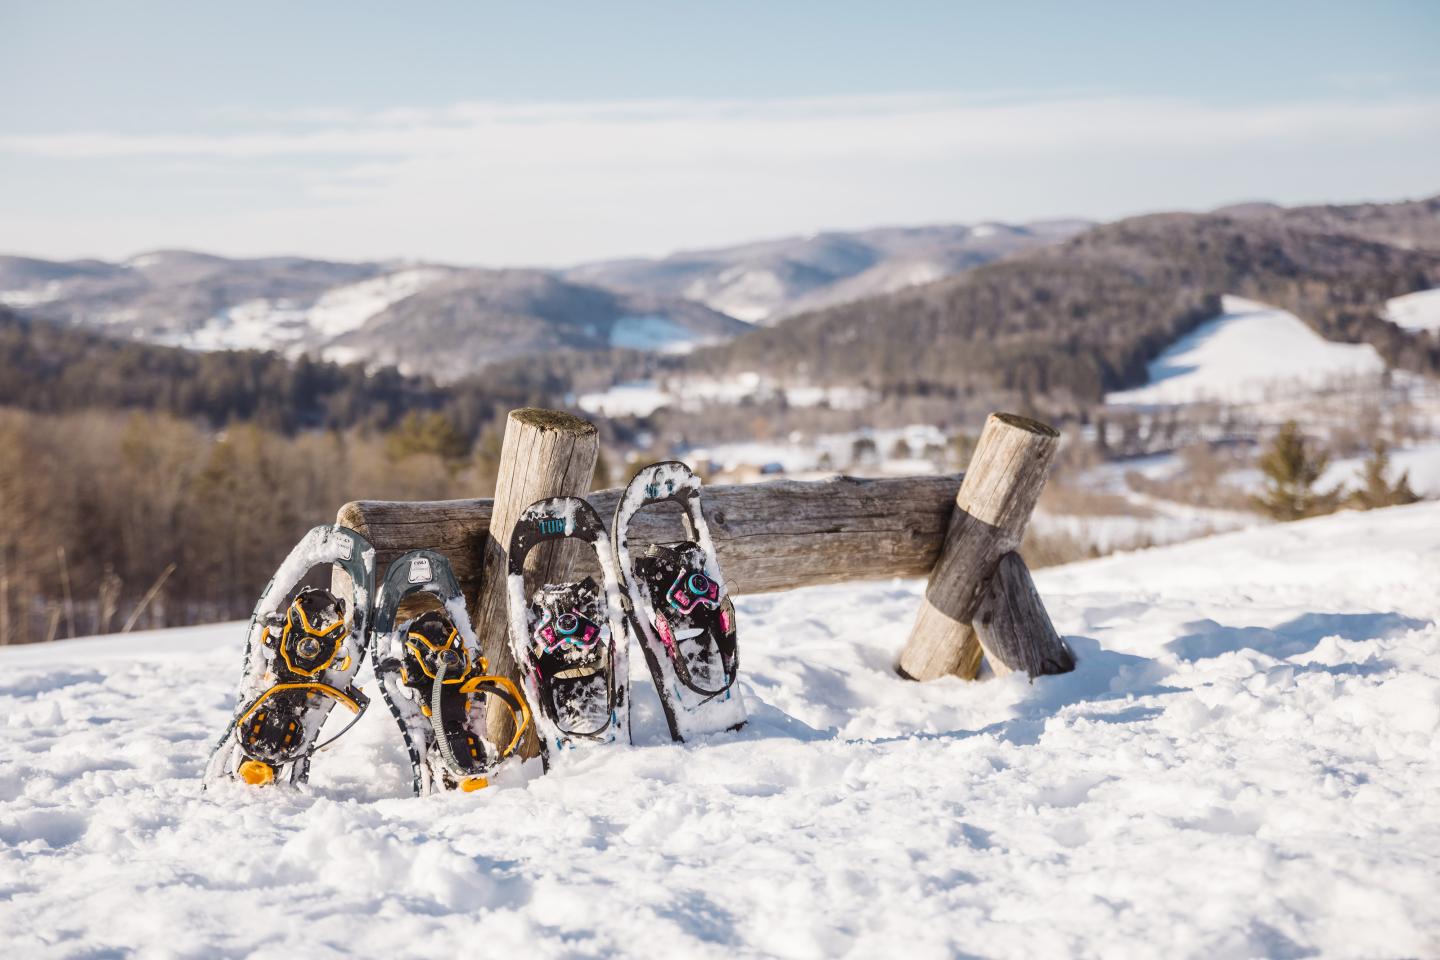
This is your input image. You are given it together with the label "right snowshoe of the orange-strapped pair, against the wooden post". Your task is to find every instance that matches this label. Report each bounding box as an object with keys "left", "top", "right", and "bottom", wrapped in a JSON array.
[{"left": 373, "top": 550, "right": 530, "bottom": 796}]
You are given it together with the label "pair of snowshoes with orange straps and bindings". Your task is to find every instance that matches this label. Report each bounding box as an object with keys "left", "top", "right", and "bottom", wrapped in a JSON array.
[{"left": 204, "top": 525, "right": 530, "bottom": 794}]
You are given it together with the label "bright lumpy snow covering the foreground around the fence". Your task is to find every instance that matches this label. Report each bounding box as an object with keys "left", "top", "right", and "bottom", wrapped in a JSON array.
[{"left": 0, "top": 504, "right": 1440, "bottom": 960}]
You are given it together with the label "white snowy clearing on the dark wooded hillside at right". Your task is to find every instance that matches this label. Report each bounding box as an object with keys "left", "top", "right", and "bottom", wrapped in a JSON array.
[{"left": 1106, "top": 296, "right": 1385, "bottom": 404}]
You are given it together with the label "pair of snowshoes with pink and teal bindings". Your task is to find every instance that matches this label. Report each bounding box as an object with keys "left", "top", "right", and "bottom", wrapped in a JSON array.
[{"left": 507, "top": 461, "right": 746, "bottom": 760}]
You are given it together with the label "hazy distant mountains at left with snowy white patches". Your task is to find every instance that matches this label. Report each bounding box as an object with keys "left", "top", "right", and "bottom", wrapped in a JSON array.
[{"left": 0, "top": 250, "right": 749, "bottom": 379}]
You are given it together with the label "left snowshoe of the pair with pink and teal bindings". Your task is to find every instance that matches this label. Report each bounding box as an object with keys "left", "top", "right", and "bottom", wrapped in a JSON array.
[{"left": 507, "top": 497, "right": 629, "bottom": 767}]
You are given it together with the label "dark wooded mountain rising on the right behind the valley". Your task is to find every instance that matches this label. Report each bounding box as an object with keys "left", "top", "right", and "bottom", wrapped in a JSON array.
[{"left": 684, "top": 204, "right": 1440, "bottom": 404}]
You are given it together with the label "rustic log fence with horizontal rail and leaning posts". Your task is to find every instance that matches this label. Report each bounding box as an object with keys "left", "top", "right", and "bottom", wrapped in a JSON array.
[{"left": 337, "top": 409, "right": 1074, "bottom": 751}]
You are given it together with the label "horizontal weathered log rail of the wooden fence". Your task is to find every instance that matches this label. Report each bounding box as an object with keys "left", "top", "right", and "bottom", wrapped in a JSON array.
[{"left": 340, "top": 474, "right": 962, "bottom": 596}]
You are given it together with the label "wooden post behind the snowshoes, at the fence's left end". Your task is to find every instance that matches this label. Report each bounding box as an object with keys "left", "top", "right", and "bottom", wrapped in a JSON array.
[{"left": 472, "top": 407, "right": 600, "bottom": 757}]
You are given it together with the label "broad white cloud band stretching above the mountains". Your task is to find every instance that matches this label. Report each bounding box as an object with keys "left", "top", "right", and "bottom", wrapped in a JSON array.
[{"left": 0, "top": 94, "right": 1440, "bottom": 263}]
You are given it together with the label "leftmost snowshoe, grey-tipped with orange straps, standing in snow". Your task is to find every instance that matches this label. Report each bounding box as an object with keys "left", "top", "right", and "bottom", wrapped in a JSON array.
[{"left": 204, "top": 524, "right": 374, "bottom": 786}]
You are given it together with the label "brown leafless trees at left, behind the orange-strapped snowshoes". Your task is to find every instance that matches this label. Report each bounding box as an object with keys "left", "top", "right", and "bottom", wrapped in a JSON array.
[{"left": 0, "top": 409, "right": 515, "bottom": 643}]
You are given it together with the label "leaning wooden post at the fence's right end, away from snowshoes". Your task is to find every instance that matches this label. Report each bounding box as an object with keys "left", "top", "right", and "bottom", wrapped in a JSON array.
[{"left": 899, "top": 413, "right": 1060, "bottom": 681}]
